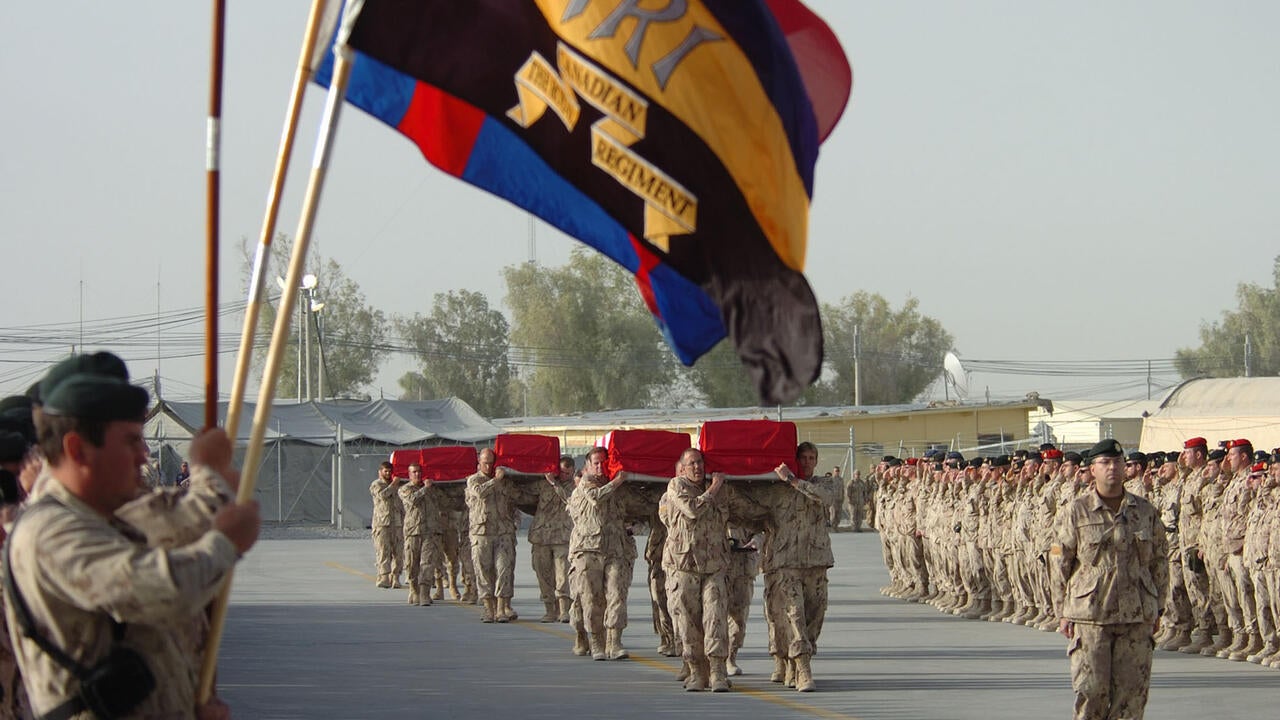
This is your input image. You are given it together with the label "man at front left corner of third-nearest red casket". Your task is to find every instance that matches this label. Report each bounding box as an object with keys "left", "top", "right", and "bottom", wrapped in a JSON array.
[{"left": 466, "top": 447, "right": 518, "bottom": 623}]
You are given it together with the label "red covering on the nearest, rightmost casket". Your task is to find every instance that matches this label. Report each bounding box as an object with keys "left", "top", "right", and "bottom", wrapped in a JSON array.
[{"left": 698, "top": 420, "right": 799, "bottom": 478}]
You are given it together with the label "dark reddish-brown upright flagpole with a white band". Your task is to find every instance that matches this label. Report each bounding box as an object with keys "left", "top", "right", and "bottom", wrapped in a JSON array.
[{"left": 205, "top": 0, "right": 227, "bottom": 428}]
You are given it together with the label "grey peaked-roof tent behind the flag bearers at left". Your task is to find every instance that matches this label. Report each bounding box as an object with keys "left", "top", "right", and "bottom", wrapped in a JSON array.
[{"left": 146, "top": 397, "right": 502, "bottom": 528}]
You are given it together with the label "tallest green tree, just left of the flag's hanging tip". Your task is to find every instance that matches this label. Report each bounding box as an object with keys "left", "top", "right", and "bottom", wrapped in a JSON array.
[{"left": 503, "top": 247, "right": 678, "bottom": 414}]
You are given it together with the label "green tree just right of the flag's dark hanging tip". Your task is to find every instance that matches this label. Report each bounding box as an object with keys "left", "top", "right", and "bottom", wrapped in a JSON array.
[{"left": 805, "top": 292, "right": 952, "bottom": 405}]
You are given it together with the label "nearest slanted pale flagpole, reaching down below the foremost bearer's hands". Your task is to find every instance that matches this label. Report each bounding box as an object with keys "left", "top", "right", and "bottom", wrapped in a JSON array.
[{"left": 196, "top": 23, "right": 352, "bottom": 705}]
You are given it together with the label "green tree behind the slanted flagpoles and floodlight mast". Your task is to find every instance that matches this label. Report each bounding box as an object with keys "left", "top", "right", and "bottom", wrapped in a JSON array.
[{"left": 241, "top": 234, "right": 388, "bottom": 398}]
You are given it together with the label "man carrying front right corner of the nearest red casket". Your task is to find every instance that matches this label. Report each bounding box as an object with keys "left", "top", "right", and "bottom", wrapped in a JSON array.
[{"left": 760, "top": 442, "right": 836, "bottom": 693}]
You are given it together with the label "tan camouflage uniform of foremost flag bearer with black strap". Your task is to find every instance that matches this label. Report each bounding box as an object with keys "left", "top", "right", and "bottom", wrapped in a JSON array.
[{"left": 6, "top": 474, "right": 237, "bottom": 719}]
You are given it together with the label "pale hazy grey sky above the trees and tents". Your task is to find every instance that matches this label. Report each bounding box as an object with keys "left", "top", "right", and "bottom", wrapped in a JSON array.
[{"left": 0, "top": 0, "right": 1280, "bottom": 397}]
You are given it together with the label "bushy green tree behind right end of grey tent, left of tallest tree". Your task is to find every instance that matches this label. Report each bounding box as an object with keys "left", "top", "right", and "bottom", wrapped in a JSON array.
[{"left": 396, "top": 290, "right": 512, "bottom": 418}]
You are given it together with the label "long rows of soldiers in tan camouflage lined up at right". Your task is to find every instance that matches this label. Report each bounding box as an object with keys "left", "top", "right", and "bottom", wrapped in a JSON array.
[{"left": 870, "top": 437, "right": 1280, "bottom": 717}]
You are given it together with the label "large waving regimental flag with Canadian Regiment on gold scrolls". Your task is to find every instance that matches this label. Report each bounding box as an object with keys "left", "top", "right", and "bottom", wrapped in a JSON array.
[{"left": 316, "top": 0, "right": 852, "bottom": 404}]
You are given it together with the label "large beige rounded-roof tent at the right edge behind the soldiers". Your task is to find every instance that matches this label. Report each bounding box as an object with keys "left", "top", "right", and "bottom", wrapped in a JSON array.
[{"left": 1142, "top": 378, "right": 1280, "bottom": 452}]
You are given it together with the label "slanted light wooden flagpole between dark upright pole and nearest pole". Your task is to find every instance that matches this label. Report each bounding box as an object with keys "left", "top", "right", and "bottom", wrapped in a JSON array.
[{"left": 225, "top": 0, "right": 328, "bottom": 442}]
